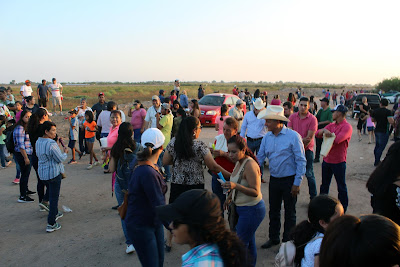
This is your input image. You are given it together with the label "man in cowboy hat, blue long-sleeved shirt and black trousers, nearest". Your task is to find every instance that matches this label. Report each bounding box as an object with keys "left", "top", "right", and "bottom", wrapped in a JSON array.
[{"left": 257, "top": 105, "right": 307, "bottom": 248}]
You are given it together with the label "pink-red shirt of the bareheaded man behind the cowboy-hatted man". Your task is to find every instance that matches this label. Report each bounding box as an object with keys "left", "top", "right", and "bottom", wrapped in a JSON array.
[{"left": 288, "top": 112, "right": 318, "bottom": 151}]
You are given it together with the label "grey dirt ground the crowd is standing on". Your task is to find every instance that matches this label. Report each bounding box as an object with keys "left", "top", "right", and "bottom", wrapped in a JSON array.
[{"left": 0, "top": 98, "right": 393, "bottom": 266}]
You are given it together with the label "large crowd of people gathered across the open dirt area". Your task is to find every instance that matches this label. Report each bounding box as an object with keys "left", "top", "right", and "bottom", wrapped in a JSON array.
[{"left": 0, "top": 81, "right": 400, "bottom": 266}]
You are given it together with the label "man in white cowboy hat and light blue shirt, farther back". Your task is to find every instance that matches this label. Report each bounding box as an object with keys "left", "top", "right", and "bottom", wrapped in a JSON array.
[{"left": 240, "top": 98, "right": 267, "bottom": 183}]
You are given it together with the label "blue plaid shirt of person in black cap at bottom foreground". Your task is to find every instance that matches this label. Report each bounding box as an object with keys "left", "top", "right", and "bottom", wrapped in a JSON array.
[{"left": 182, "top": 244, "right": 224, "bottom": 267}]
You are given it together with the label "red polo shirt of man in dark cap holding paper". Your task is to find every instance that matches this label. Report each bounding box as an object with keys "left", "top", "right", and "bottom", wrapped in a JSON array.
[{"left": 317, "top": 119, "right": 353, "bottom": 164}]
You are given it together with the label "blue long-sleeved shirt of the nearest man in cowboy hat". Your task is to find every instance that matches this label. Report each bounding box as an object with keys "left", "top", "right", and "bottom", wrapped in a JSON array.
[{"left": 257, "top": 126, "right": 307, "bottom": 186}]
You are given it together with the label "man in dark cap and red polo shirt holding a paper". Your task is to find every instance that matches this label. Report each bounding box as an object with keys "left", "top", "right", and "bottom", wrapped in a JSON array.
[{"left": 316, "top": 105, "right": 353, "bottom": 211}]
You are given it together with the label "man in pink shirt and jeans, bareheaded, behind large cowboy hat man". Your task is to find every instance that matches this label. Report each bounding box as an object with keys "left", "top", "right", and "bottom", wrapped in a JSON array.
[{"left": 288, "top": 97, "right": 318, "bottom": 200}]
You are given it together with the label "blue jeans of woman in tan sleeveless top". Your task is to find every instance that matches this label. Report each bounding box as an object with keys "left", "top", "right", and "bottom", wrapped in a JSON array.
[{"left": 236, "top": 199, "right": 266, "bottom": 266}]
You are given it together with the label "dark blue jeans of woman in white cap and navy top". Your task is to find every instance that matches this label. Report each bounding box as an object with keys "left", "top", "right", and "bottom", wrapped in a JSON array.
[{"left": 128, "top": 224, "right": 164, "bottom": 267}]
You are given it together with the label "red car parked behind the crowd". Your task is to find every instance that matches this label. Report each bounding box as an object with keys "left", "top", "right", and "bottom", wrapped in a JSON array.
[{"left": 199, "top": 93, "right": 246, "bottom": 125}]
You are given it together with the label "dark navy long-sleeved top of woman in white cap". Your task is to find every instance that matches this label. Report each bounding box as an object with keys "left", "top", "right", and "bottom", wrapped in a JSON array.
[{"left": 125, "top": 165, "right": 167, "bottom": 228}]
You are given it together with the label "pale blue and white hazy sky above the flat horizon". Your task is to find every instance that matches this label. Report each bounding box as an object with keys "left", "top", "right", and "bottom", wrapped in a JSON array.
[{"left": 0, "top": 0, "right": 400, "bottom": 85}]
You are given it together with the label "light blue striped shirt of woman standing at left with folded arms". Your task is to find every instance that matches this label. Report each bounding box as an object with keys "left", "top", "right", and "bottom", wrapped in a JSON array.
[{"left": 36, "top": 137, "right": 68, "bottom": 180}]
